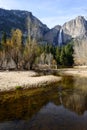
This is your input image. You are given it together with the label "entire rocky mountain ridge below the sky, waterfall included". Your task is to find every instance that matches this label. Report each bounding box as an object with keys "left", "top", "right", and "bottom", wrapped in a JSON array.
[{"left": 0, "top": 8, "right": 87, "bottom": 46}]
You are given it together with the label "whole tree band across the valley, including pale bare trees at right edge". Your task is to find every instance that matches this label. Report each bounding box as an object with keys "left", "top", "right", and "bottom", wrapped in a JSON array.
[{"left": 0, "top": 17, "right": 87, "bottom": 70}]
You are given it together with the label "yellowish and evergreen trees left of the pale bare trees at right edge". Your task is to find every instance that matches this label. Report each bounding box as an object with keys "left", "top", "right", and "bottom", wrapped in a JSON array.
[{"left": 0, "top": 29, "right": 73, "bottom": 70}]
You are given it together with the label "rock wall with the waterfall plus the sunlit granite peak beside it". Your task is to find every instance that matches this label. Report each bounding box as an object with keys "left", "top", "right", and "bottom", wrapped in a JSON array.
[{"left": 45, "top": 16, "right": 87, "bottom": 46}]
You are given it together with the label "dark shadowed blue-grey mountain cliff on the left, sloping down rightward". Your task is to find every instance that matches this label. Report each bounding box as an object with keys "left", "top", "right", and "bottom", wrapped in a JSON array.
[{"left": 0, "top": 9, "right": 49, "bottom": 39}]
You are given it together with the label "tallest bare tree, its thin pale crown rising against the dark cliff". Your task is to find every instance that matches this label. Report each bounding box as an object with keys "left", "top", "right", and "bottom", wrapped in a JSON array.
[{"left": 23, "top": 16, "right": 38, "bottom": 69}]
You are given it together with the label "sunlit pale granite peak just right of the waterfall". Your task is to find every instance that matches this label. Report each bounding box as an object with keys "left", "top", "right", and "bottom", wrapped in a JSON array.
[{"left": 62, "top": 16, "right": 87, "bottom": 42}]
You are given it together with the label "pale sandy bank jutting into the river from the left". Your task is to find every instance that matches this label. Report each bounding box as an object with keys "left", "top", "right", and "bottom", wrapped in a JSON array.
[{"left": 0, "top": 71, "right": 61, "bottom": 91}]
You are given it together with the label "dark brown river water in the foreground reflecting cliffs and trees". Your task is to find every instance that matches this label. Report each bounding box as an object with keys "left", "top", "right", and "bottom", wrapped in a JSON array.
[{"left": 0, "top": 77, "right": 87, "bottom": 130}]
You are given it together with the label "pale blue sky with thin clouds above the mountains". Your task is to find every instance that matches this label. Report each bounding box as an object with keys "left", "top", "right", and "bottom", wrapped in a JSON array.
[{"left": 0, "top": 0, "right": 87, "bottom": 28}]
